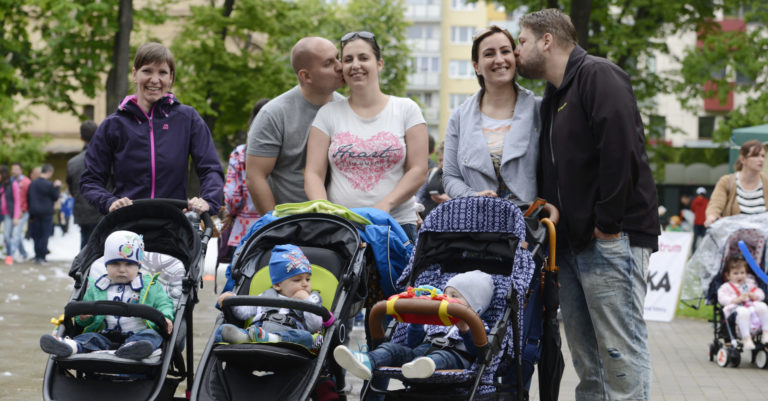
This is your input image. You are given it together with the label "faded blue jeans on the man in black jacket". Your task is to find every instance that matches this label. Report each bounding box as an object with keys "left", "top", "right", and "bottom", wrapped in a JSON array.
[{"left": 558, "top": 233, "right": 651, "bottom": 401}]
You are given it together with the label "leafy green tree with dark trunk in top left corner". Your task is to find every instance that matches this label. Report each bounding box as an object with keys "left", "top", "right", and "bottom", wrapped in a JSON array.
[{"left": 0, "top": 0, "right": 164, "bottom": 163}]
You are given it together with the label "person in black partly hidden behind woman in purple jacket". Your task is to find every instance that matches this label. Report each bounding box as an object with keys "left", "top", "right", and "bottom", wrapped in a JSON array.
[{"left": 67, "top": 120, "right": 101, "bottom": 249}]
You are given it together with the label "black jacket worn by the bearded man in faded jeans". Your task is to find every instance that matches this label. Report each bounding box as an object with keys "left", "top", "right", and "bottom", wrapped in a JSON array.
[{"left": 539, "top": 46, "right": 660, "bottom": 251}]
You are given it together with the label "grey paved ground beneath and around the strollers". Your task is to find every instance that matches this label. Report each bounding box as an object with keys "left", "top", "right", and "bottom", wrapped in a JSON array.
[{"left": 0, "top": 245, "right": 768, "bottom": 401}]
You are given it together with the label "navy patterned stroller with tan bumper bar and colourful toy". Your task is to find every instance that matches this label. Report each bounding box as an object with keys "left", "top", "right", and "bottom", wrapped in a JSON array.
[{"left": 361, "top": 197, "right": 559, "bottom": 400}]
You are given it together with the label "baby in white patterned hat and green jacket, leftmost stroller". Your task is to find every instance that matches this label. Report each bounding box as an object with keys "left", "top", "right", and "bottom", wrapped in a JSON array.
[{"left": 40, "top": 230, "right": 174, "bottom": 360}]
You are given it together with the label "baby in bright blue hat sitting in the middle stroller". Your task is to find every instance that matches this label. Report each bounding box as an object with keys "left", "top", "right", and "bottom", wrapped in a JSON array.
[{"left": 216, "top": 244, "right": 323, "bottom": 350}]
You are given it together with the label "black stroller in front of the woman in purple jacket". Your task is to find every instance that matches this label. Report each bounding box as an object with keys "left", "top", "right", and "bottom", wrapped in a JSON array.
[{"left": 43, "top": 199, "right": 213, "bottom": 401}]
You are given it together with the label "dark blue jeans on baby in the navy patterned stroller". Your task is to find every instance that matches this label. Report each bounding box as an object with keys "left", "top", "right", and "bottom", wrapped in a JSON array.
[{"left": 368, "top": 342, "right": 469, "bottom": 370}]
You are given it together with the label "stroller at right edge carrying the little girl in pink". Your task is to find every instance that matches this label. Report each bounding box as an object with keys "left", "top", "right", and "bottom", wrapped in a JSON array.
[{"left": 706, "top": 228, "right": 768, "bottom": 369}]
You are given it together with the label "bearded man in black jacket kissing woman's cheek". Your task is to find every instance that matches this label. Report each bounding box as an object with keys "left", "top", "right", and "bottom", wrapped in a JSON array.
[{"left": 515, "top": 9, "right": 660, "bottom": 400}]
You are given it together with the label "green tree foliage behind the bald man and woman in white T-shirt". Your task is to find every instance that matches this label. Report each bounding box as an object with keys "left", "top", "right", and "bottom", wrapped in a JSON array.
[{"left": 172, "top": 0, "right": 408, "bottom": 156}]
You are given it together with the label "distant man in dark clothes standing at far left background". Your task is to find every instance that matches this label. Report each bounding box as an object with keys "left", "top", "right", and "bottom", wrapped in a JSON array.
[{"left": 27, "top": 164, "right": 61, "bottom": 265}]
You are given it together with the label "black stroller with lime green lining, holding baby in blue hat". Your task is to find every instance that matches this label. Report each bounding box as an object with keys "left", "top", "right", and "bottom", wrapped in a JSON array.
[{"left": 191, "top": 213, "right": 365, "bottom": 401}]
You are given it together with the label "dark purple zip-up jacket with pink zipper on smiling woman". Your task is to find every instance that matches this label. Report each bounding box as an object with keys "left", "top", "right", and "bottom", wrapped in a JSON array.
[{"left": 80, "top": 93, "right": 224, "bottom": 214}]
